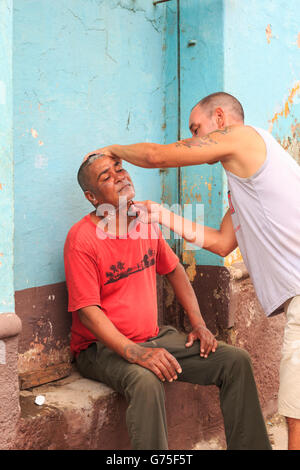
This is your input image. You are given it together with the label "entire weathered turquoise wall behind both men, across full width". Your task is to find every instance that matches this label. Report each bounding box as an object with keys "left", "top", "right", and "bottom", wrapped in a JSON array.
[{"left": 4, "top": 0, "right": 300, "bottom": 294}]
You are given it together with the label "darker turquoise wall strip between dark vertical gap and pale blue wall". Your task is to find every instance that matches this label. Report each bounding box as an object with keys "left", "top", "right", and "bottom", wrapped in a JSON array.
[{"left": 180, "top": 0, "right": 224, "bottom": 265}]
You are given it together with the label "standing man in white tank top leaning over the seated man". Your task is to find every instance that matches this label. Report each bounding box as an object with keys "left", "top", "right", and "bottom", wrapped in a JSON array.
[{"left": 89, "top": 92, "right": 300, "bottom": 450}]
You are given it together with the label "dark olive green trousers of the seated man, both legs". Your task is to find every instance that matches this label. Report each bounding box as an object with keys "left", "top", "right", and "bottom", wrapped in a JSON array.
[{"left": 76, "top": 326, "right": 272, "bottom": 450}]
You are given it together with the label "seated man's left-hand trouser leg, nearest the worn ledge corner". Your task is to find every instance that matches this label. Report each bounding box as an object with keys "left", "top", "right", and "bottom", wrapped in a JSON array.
[{"left": 77, "top": 343, "right": 168, "bottom": 450}]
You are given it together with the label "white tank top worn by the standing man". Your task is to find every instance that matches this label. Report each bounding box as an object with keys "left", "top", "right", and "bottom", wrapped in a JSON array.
[{"left": 225, "top": 127, "right": 300, "bottom": 315}]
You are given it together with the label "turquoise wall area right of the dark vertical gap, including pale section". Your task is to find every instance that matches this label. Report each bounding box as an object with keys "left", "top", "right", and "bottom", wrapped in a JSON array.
[{"left": 163, "top": 0, "right": 300, "bottom": 265}]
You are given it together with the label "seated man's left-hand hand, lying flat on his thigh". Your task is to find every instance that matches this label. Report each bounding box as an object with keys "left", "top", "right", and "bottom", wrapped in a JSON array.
[{"left": 124, "top": 345, "right": 182, "bottom": 382}]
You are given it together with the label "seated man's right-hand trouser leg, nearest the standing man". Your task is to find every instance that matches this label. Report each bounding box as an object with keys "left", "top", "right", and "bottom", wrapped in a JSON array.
[{"left": 148, "top": 329, "right": 271, "bottom": 450}]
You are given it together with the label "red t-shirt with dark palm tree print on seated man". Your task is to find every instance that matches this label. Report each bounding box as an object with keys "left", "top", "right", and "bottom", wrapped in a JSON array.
[{"left": 64, "top": 214, "right": 179, "bottom": 356}]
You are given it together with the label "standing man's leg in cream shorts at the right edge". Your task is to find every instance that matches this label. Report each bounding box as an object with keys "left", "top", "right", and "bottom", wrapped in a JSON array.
[{"left": 278, "top": 295, "right": 300, "bottom": 450}]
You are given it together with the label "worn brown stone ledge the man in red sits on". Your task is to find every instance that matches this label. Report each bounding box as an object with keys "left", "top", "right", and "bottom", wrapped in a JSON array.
[{"left": 13, "top": 370, "right": 225, "bottom": 450}]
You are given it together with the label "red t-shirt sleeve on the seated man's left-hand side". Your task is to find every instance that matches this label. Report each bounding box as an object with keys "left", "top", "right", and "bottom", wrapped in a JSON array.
[{"left": 64, "top": 248, "right": 101, "bottom": 312}]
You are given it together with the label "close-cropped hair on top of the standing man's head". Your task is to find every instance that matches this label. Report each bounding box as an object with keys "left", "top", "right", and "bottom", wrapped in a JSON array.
[{"left": 193, "top": 91, "right": 244, "bottom": 122}]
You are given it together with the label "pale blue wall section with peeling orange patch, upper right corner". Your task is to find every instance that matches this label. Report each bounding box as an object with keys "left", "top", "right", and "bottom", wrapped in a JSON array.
[{"left": 224, "top": 0, "right": 300, "bottom": 152}]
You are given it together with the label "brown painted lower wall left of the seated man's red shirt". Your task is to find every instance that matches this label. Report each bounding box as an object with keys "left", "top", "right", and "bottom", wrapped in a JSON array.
[{"left": 15, "top": 282, "right": 71, "bottom": 388}]
